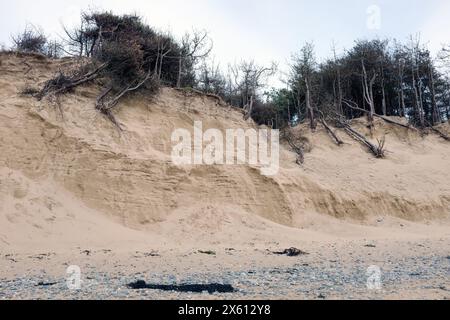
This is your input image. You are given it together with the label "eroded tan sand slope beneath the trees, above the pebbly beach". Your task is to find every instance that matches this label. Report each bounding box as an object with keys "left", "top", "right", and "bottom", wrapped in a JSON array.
[{"left": 0, "top": 54, "right": 450, "bottom": 250}]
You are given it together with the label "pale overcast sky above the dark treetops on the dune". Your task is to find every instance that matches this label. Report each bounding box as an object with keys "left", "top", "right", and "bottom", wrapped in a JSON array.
[{"left": 0, "top": 0, "right": 450, "bottom": 84}]
